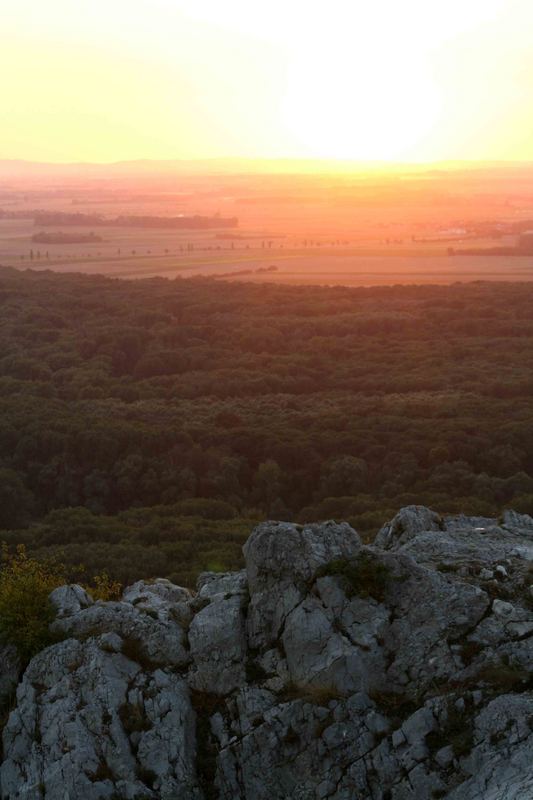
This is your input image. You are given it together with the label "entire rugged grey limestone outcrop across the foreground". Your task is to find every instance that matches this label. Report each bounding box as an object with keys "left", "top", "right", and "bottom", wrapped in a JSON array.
[{"left": 0, "top": 506, "right": 533, "bottom": 800}]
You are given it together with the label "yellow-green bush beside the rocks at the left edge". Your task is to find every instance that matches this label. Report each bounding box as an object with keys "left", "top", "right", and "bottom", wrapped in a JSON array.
[{"left": 0, "top": 544, "right": 65, "bottom": 660}]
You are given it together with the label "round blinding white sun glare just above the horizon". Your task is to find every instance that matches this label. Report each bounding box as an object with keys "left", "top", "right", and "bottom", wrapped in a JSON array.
[{"left": 283, "top": 24, "right": 440, "bottom": 161}]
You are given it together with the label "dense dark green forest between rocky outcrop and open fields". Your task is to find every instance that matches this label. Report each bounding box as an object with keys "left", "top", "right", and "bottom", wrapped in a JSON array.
[{"left": 0, "top": 268, "right": 533, "bottom": 584}]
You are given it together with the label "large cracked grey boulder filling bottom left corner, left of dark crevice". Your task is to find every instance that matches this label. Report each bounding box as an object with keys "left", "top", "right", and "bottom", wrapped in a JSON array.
[{"left": 0, "top": 639, "right": 201, "bottom": 800}]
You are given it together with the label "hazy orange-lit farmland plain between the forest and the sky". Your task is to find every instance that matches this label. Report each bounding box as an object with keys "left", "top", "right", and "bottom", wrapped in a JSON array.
[{"left": 0, "top": 160, "right": 533, "bottom": 285}]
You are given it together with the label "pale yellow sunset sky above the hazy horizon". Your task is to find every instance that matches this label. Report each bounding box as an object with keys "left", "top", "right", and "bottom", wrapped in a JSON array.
[{"left": 4, "top": 0, "right": 533, "bottom": 162}]
